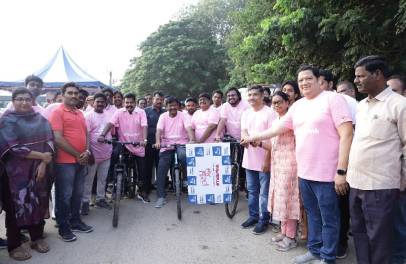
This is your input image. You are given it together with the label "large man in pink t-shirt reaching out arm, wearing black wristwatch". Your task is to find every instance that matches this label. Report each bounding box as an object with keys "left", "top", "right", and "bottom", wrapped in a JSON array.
[{"left": 242, "top": 65, "right": 353, "bottom": 263}]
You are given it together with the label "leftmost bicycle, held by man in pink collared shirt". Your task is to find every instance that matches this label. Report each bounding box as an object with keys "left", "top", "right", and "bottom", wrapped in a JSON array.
[{"left": 104, "top": 139, "right": 140, "bottom": 227}]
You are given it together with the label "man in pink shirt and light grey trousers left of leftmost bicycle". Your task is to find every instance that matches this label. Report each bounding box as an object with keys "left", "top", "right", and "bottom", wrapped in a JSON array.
[{"left": 81, "top": 93, "right": 112, "bottom": 215}]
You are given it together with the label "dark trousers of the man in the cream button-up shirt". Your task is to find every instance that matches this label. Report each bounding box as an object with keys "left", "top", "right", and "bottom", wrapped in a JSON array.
[{"left": 350, "top": 188, "right": 399, "bottom": 264}]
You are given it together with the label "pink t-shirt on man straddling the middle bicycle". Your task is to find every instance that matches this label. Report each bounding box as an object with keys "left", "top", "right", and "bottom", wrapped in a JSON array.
[{"left": 156, "top": 112, "right": 190, "bottom": 152}]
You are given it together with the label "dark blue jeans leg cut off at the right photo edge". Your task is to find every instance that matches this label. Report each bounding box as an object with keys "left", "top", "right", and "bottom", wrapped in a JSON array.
[{"left": 391, "top": 194, "right": 406, "bottom": 264}]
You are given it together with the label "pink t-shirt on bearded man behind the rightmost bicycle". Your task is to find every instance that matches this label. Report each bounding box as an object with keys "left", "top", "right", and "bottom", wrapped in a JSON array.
[{"left": 220, "top": 100, "right": 250, "bottom": 139}]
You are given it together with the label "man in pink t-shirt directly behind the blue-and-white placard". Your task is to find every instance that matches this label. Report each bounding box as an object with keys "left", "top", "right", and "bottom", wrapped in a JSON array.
[{"left": 190, "top": 93, "right": 220, "bottom": 143}]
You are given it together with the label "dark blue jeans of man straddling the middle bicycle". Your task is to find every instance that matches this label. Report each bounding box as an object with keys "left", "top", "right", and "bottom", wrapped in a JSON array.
[{"left": 156, "top": 147, "right": 186, "bottom": 198}]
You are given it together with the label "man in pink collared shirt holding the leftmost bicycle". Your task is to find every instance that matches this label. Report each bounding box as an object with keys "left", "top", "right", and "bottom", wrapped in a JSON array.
[{"left": 99, "top": 93, "right": 149, "bottom": 203}]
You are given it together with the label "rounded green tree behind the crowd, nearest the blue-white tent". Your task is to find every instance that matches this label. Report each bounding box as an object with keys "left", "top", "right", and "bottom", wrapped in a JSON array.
[{"left": 122, "top": 18, "right": 228, "bottom": 98}]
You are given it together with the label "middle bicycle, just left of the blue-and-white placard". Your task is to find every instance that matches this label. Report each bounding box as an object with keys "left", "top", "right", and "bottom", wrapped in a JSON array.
[{"left": 161, "top": 144, "right": 186, "bottom": 220}]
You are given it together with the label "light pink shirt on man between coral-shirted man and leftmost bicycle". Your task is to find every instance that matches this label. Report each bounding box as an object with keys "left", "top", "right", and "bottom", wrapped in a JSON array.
[{"left": 85, "top": 111, "right": 112, "bottom": 162}]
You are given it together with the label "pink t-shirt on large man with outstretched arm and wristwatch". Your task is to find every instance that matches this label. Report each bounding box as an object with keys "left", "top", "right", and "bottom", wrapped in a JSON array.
[{"left": 280, "top": 91, "right": 352, "bottom": 182}]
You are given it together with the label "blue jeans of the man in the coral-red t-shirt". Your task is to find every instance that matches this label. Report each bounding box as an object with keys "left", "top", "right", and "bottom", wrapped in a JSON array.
[{"left": 55, "top": 163, "right": 86, "bottom": 230}]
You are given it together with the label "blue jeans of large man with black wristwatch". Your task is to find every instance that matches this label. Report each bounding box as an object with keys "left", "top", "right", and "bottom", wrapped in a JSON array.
[{"left": 299, "top": 178, "right": 340, "bottom": 262}]
